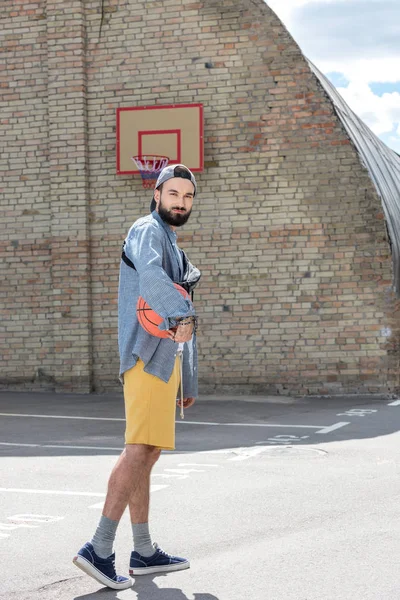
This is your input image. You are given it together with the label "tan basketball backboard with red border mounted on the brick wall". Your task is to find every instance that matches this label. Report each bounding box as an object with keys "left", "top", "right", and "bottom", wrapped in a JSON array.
[{"left": 117, "top": 104, "right": 204, "bottom": 175}]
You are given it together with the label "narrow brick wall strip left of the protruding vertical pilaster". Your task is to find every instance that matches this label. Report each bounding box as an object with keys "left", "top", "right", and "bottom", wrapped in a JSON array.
[{"left": 0, "top": 2, "right": 54, "bottom": 387}]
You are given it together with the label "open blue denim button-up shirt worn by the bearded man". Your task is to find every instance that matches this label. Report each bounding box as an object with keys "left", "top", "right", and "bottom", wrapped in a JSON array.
[{"left": 118, "top": 211, "right": 198, "bottom": 398}]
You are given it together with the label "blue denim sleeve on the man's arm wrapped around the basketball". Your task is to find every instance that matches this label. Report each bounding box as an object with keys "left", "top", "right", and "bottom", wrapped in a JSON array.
[{"left": 125, "top": 223, "right": 195, "bottom": 330}]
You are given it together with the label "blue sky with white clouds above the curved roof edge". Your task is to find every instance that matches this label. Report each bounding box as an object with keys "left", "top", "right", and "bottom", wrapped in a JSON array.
[{"left": 266, "top": 0, "right": 400, "bottom": 153}]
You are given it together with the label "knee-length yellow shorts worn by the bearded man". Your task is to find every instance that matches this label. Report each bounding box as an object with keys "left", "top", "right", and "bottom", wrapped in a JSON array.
[{"left": 124, "top": 356, "right": 180, "bottom": 450}]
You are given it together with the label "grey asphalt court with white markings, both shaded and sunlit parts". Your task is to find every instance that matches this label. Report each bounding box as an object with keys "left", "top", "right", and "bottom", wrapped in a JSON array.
[{"left": 0, "top": 392, "right": 400, "bottom": 600}]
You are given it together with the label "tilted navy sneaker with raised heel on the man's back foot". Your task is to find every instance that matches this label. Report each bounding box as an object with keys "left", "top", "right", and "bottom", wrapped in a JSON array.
[{"left": 72, "top": 542, "right": 133, "bottom": 590}]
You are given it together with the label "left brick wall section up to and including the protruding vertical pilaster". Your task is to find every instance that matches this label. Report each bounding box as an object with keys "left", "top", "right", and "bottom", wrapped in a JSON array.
[{"left": 1, "top": 0, "right": 92, "bottom": 391}]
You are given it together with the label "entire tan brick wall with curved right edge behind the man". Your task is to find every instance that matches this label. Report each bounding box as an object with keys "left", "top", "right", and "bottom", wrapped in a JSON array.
[{"left": 3, "top": 0, "right": 399, "bottom": 393}]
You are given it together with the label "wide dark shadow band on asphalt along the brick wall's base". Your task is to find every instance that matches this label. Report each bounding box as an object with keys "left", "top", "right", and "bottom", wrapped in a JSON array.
[{"left": 0, "top": 392, "right": 400, "bottom": 457}]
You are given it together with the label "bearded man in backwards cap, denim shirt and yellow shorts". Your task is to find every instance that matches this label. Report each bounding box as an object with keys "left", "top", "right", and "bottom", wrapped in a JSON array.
[{"left": 73, "top": 165, "right": 200, "bottom": 589}]
